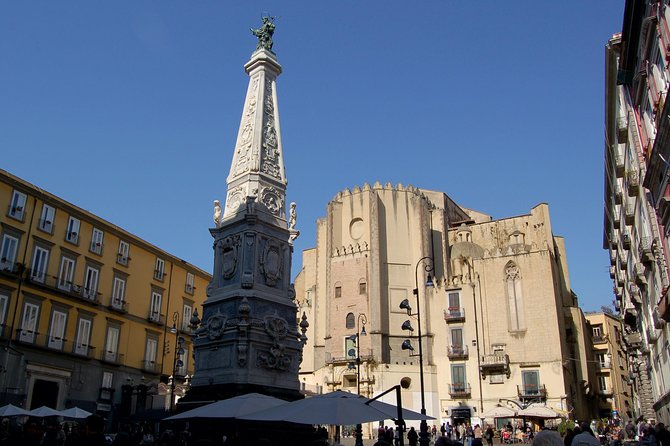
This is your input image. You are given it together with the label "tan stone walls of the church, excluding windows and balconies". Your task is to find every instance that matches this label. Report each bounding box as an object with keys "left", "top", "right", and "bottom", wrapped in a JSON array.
[{"left": 296, "top": 185, "right": 592, "bottom": 420}]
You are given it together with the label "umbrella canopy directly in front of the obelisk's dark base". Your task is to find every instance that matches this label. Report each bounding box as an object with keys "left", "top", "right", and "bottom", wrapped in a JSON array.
[{"left": 165, "top": 393, "right": 287, "bottom": 421}]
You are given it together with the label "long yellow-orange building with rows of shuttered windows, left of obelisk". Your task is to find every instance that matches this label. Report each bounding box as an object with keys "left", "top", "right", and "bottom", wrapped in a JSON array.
[{"left": 0, "top": 170, "right": 211, "bottom": 418}]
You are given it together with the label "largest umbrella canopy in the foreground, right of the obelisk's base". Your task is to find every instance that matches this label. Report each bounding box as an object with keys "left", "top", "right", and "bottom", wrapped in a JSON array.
[{"left": 239, "top": 392, "right": 388, "bottom": 425}]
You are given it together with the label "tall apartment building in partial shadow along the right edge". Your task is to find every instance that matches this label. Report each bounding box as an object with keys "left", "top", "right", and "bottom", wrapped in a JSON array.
[{"left": 603, "top": 0, "right": 670, "bottom": 423}]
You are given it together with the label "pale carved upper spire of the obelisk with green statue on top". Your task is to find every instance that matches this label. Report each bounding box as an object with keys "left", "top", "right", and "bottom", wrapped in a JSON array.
[{"left": 223, "top": 17, "right": 287, "bottom": 225}]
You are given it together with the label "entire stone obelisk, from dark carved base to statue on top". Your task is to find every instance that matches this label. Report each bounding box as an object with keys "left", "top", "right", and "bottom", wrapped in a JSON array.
[{"left": 180, "top": 17, "right": 307, "bottom": 408}]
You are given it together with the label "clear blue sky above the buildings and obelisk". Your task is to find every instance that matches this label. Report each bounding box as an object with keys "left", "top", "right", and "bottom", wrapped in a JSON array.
[{"left": 0, "top": 0, "right": 624, "bottom": 310}]
